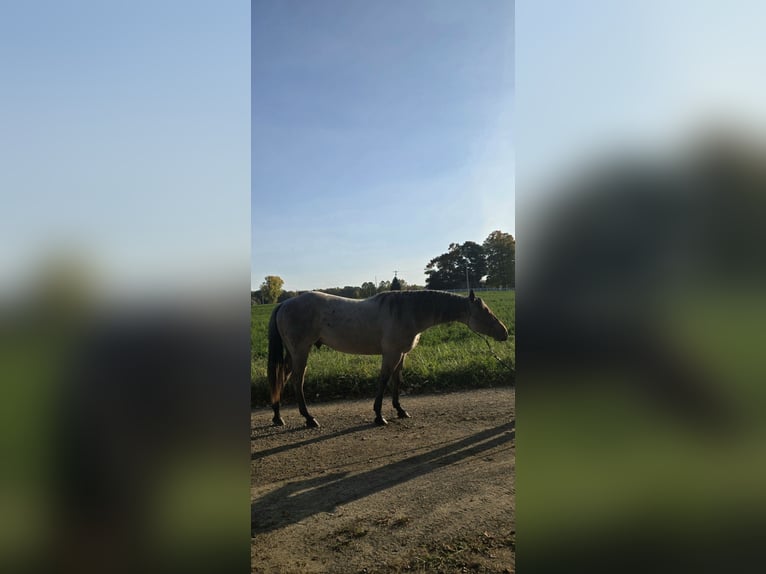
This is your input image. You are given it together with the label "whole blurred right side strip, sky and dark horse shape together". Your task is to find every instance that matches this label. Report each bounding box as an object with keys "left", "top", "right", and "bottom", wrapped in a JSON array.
[{"left": 515, "top": 1, "right": 766, "bottom": 573}]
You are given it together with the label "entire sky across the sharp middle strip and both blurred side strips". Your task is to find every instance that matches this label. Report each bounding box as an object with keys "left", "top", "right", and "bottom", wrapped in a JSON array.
[{"left": 0, "top": 4, "right": 766, "bottom": 300}]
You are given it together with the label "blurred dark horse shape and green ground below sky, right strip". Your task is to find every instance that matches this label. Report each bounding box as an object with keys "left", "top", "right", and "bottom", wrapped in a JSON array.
[{"left": 517, "top": 129, "right": 766, "bottom": 573}]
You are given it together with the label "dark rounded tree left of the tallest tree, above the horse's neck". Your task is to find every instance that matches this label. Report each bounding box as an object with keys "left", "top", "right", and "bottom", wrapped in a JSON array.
[{"left": 426, "top": 241, "right": 487, "bottom": 289}]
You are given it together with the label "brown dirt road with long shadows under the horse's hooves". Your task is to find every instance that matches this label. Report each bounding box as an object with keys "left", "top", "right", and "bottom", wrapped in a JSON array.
[{"left": 250, "top": 388, "right": 515, "bottom": 573}]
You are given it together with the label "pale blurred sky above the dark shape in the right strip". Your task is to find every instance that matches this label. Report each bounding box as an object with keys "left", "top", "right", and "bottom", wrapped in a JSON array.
[{"left": 515, "top": 0, "right": 766, "bottom": 192}]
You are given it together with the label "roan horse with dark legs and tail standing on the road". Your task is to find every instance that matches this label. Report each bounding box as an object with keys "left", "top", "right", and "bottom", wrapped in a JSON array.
[{"left": 268, "top": 290, "right": 508, "bottom": 427}]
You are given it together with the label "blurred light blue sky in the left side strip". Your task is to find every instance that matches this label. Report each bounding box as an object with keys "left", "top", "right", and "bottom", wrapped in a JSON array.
[{"left": 0, "top": 0, "right": 250, "bottom": 296}]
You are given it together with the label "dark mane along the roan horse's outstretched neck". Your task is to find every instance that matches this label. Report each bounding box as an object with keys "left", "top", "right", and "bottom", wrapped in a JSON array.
[{"left": 372, "top": 290, "right": 466, "bottom": 324}]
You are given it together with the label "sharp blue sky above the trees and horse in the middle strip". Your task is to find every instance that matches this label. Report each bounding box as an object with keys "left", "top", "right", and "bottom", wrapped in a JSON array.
[{"left": 251, "top": 0, "right": 515, "bottom": 290}]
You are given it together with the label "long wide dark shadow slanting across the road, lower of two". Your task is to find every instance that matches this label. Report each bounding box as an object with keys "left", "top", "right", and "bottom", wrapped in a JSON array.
[{"left": 250, "top": 420, "right": 516, "bottom": 536}]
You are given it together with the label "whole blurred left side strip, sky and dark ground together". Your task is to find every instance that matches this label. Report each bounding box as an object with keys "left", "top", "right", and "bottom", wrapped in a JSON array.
[{"left": 0, "top": 0, "right": 250, "bottom": 572}]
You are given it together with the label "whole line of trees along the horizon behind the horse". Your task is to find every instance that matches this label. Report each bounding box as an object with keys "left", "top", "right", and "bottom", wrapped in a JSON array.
[{"left": 250, "top": 230, "right": 516, "bottom": 304}]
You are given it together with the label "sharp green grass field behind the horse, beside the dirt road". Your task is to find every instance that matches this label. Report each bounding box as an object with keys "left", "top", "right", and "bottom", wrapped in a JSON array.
[{"left": 250, "top": 291, "right": 516, "bottom": 405}]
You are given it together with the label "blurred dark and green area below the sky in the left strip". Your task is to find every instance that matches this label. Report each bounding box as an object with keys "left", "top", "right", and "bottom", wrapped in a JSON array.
[{"left": 0, "top": 276, "right": 249, "bottom": 572}]
